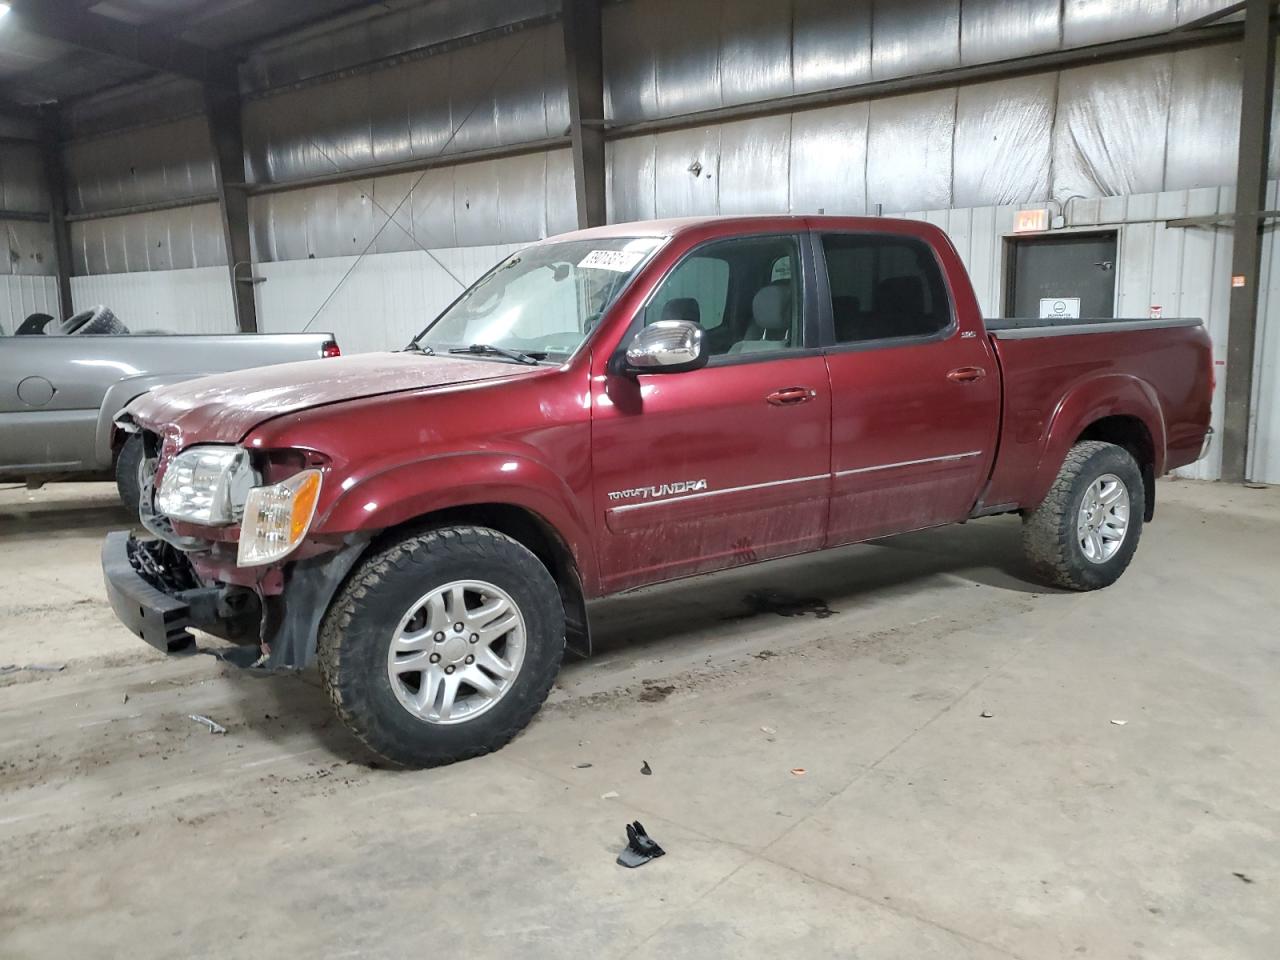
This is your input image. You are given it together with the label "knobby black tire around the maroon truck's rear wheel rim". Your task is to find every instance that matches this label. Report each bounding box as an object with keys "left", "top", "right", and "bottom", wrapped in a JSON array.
[{"left": 1023, "top": 440, "right": 1147, "bottom": 591}]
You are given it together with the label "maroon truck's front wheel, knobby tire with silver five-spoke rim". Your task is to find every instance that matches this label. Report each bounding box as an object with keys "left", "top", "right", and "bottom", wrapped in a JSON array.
[{"left": 319, "top": 526, "right": 564, "bottom": 767}]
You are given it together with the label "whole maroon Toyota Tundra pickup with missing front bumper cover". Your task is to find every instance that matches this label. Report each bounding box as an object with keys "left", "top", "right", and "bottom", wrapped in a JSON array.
[{"left": 102, "top": 216, "right": 1212, "bottom": 765}]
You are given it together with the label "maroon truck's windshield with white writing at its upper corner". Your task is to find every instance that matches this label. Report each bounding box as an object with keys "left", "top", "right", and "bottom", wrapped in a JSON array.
[{"left": 413, "top": 237, "right": 663, "bottom": 360}]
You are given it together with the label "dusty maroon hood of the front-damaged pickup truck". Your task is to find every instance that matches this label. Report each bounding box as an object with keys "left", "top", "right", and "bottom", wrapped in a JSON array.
[{"left": 125, "top": 353, "right": 547, "bottom": 449}]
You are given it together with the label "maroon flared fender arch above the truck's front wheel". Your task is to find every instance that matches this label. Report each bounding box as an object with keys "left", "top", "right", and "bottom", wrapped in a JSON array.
[{"left": 320, "top": 452, "right": 598, "bottom": 595}]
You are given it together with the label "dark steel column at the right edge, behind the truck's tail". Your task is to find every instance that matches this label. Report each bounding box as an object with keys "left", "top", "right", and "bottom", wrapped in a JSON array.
[{"left": 1222, "top": 0, "right": 1276, "bottom": 483}]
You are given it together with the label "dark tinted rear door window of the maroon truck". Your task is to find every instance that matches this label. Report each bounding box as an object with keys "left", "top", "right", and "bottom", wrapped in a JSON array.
[{"left": 822, "top": 234, "right": 951, "bottom": 343}]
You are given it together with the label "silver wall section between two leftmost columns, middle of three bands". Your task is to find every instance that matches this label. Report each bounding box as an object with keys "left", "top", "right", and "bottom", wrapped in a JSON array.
[{"left": 63, "top": 116, "right": 216, "bottom": 214}]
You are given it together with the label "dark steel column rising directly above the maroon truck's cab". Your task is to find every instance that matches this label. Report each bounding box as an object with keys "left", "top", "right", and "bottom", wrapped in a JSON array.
[{"left": 561, "top": 0, "right": 605, "bottom": 227}]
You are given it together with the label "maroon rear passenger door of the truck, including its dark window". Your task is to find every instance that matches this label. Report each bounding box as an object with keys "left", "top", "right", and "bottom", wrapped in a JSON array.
[{"left": 814, "top": 232, "right": 1000, "bottom": 545}]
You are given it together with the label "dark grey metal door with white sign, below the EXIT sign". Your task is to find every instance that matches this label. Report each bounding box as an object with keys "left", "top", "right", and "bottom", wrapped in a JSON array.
[{"left": 1005, "top": 233, "right": 1116, "bottom": 317}]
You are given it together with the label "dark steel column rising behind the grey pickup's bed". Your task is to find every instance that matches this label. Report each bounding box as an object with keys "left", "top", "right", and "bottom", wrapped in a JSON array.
[{"left": 205, "top": 87, "right": 257, "bottom": 333}]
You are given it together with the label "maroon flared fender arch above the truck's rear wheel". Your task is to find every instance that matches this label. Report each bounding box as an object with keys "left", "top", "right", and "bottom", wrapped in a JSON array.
[{"left": 1021, "top": 374, "right": 1166, "bottom": 506}]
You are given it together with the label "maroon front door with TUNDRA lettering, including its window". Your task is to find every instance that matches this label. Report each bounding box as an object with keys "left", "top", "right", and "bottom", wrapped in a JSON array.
[{"left": 591, "top": 234, "right": 831, "bottom": 593}]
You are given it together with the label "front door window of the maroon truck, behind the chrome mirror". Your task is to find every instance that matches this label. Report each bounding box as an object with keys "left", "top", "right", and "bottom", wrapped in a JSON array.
[{"left": 644, "top": 237, "right": 804, "bottom": 357}]
